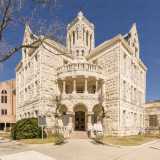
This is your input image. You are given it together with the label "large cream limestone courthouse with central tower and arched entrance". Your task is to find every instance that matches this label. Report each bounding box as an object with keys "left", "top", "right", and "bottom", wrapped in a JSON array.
[{"left": 15, "top": 11, "right": 147, "bottom": 136}]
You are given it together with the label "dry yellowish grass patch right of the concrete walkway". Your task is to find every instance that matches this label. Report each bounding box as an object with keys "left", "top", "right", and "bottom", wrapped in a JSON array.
[{"left": 102, "top": 135, "right": 160, "bottom": 146}]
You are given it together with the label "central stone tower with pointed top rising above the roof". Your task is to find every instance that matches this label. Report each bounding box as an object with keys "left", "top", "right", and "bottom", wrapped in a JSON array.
[{"left": 66, "top": 11, "right": 95, "bottom": 58}]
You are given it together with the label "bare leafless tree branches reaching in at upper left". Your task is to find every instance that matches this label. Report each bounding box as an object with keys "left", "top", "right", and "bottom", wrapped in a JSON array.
[{"left": 0, "top": 0, "right": 65, "bottom": 63}]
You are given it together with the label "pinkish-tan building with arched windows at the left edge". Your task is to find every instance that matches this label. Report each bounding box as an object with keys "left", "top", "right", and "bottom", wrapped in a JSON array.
[{"left": 0, "top": 79, "right": 16, "bottom": 131}]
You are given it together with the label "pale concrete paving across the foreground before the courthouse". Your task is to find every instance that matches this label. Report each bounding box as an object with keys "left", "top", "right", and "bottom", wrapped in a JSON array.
[{"left": 0, "top": 139, "right": 160, "bottom": 160}]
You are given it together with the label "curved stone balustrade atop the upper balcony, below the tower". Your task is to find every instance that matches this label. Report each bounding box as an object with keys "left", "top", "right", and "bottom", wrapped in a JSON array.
[{"left": 56, "top": 63, "right": 104, "bottom": 78}]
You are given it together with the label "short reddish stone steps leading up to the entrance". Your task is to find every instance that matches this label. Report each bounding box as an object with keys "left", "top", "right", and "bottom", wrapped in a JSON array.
[{"left": 70, "top": 131, "right": 88, "bottom": 139}]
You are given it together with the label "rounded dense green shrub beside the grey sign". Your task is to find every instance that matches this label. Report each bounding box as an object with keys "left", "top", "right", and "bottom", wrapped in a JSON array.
[{"left": 11, "top": 117, "right": 44, "bottom": 139}]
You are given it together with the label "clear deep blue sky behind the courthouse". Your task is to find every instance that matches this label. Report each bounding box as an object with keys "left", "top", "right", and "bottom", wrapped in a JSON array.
[{"left": 0, "top": 0, "right": 160, "bottom": 101}]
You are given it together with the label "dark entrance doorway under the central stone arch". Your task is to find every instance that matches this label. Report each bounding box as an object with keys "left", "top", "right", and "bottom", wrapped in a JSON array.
[{"left": 75, "top": 111, "right": 85, "bottom": 131}]
